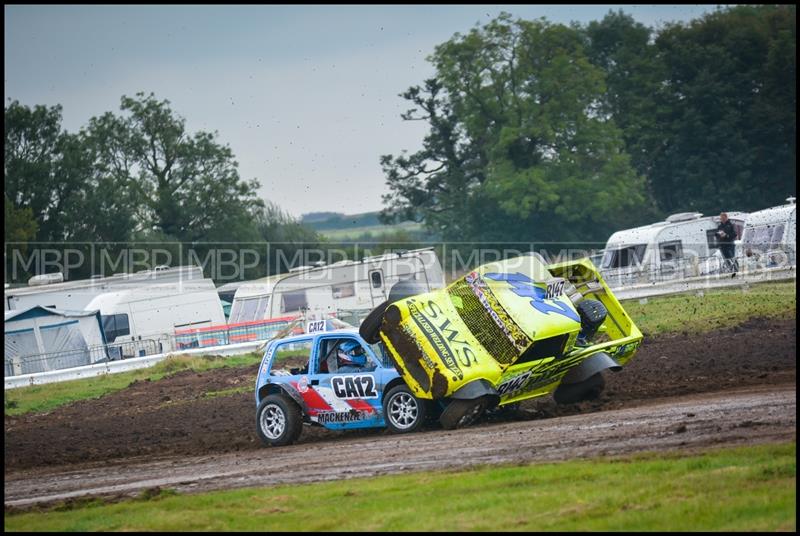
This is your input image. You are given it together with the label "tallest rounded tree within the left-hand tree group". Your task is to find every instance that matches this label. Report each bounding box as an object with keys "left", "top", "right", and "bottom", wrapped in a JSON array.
[{"left": 82, "top": 93, "right": 263, "bottom": 242}]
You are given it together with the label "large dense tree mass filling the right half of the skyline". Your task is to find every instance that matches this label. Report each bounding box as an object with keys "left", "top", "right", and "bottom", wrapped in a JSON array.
[{"left": 381, "top": 6, "right": 796, "bottom": 242}]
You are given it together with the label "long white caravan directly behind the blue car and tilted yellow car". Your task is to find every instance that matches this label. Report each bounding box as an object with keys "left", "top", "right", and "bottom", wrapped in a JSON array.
[{"left": 228, "top": 248, "right": 444, "bottom": 324}]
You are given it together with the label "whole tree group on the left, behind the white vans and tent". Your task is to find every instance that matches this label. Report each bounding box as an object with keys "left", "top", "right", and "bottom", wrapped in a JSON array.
[{"left": 4, "top": 93, "right": 320, "bottom": 278}]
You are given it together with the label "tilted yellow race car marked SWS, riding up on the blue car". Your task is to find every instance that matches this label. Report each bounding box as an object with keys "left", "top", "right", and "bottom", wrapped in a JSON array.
[{"left": 360, "top": 253, "right": 642, "bottom": 429}]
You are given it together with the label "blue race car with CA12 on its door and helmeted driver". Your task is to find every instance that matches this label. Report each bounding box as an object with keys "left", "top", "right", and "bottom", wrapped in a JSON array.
[{"left": 255, "top": 330, "right": 429, "bottom": 446}]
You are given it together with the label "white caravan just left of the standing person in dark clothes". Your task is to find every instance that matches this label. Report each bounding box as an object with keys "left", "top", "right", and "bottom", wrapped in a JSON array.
[{"left": 600, "top": 212, "right": 748, "bottom": 287}]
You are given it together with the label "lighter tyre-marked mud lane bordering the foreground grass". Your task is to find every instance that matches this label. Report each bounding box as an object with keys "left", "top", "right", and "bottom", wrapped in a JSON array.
[{"left": 5, "top": 384, "right": 796, "bottom": 510}]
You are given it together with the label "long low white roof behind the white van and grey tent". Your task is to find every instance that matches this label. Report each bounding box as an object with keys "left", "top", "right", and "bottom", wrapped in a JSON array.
[{"left": 3, "top": 266, "right": 203, "bottom": 311}]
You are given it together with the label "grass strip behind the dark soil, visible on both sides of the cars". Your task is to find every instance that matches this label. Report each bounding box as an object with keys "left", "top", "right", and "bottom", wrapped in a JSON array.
[{"left": 3, "top": 281, "right": 797, "bottom": 415}]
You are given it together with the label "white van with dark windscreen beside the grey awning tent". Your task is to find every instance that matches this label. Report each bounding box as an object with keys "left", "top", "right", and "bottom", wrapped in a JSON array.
[{"left": 87, "top": 279, "right": 225, "bottom": 357}]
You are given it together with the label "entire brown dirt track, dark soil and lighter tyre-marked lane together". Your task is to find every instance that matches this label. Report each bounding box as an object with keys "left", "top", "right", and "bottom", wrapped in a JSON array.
[{"left": 5, "top": 319, "right": 796, "bottom": 507}]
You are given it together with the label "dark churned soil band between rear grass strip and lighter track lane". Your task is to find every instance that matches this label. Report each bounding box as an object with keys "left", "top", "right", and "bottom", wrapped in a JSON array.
[{"left": 5, "top": 319, "right": 796, "bottom": 473}]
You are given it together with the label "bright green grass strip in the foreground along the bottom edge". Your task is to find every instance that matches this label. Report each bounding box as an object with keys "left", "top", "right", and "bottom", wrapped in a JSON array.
[{"left": 5, "top": 443, "right": 797, "bottom": 532}]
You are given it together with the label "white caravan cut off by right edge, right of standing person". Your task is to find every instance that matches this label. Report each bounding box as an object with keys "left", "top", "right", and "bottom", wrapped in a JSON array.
[{"left": 739, "top": 197, "right": 797, "bottom": 270}]
